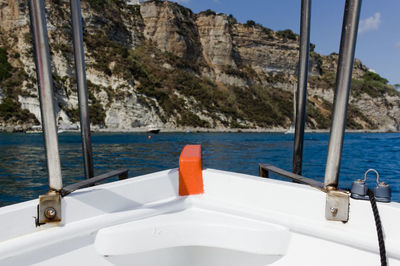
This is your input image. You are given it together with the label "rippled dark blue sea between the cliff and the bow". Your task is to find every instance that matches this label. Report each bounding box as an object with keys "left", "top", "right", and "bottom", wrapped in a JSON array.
[{"left": 0, "top": 133, "right": 400, "bottom": 206}]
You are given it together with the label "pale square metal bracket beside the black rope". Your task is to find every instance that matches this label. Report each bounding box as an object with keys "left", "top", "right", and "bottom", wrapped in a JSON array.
[{"left": 325, "top": 190, "right": 350, "bottom": 222}]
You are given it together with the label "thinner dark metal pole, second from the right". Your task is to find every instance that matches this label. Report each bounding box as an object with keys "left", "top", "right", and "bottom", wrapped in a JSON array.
[{"left": 293, "top": 0, "right": 311, "bottom": 175}]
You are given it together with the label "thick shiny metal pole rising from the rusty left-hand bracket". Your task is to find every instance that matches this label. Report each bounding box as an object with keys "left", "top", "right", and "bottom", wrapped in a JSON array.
[{"left": 29, "top": 0, "right": 62, "bottom": 191}]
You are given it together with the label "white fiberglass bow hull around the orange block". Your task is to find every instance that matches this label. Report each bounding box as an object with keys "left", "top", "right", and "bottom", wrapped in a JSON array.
[{"left": 0, "top": 169, "right": 400, "bottom": 266}]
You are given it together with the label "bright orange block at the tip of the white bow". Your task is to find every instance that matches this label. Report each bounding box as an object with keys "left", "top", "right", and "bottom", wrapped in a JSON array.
[{"left": 179, "top": 145, "right": 204, "bottom": 196}]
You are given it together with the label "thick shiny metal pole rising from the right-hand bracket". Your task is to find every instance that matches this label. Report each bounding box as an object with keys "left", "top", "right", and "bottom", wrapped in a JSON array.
[{"left": 324, "top": 0, "right": 361, "bottom": 188}]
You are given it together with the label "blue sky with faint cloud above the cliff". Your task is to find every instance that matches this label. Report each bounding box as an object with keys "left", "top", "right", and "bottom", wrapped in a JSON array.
[{"left": 171, "top": 0, "right": 400, "bottom": 84}]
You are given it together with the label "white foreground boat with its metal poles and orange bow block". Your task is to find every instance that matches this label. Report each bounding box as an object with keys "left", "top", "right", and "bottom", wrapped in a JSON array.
[{"left": 0, "top": 0, "right": 400, "bottom": 266}]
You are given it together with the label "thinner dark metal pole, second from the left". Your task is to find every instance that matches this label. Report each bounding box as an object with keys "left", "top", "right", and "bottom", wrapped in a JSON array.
[{"left": 71, "top": 0, "right": 94, "bottom": 179}]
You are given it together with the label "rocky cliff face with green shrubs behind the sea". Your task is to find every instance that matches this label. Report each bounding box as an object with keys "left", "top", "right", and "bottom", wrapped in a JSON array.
[{"left": 0, "top": 0, "right": 400, "bottom": 130}]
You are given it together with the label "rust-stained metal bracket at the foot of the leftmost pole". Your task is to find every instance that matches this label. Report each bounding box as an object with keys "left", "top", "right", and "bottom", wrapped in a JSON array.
[{"left": 36, "top": 191, "right": 61, "bottom": 226}]
